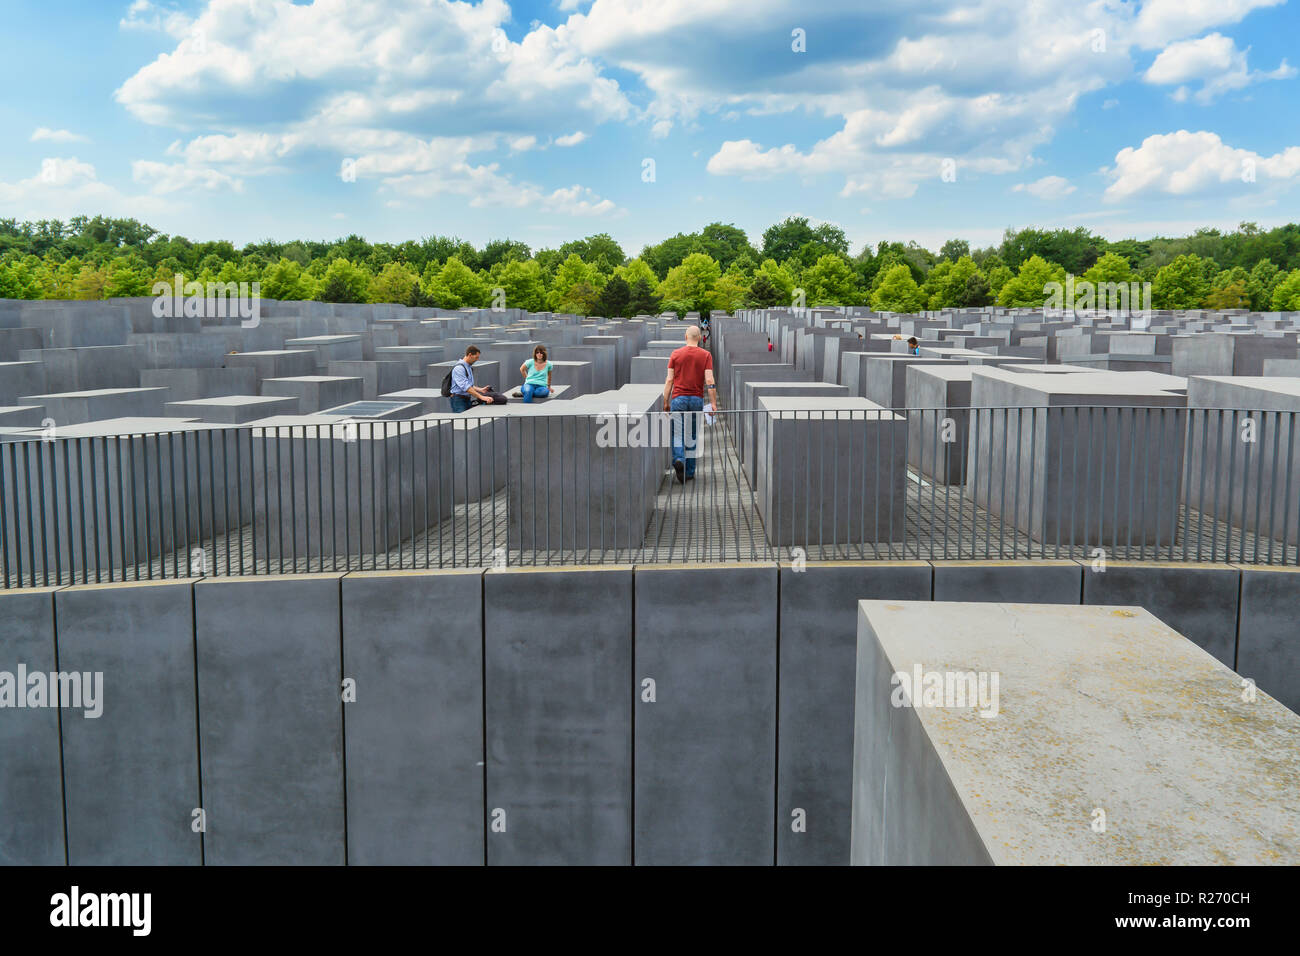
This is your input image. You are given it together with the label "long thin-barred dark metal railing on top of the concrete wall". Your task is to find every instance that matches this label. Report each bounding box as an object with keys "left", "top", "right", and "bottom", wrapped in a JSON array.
[{"left": 0, "top": 399, "right": 1300, "bottom": 588}]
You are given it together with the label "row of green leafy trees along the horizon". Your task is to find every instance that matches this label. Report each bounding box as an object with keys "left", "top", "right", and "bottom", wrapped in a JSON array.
[{"left": 0, "top": 216, "right": 1300, "bottom": 316}]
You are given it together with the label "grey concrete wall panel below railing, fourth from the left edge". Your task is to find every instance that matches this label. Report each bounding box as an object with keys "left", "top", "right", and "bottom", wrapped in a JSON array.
[{"left": 343, "top": 571, "right": 485, "bottom": 866}]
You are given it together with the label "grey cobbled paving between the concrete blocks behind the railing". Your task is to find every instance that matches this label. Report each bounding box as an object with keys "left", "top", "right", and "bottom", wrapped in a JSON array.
[{"left": 7, "top": 423, "right": 1300, "bottom": 587}]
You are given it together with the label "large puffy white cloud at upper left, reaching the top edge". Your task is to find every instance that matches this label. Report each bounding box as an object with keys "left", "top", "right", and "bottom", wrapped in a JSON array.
[{"left": 116, "top": 0, "right": 636, "bottom": 215}]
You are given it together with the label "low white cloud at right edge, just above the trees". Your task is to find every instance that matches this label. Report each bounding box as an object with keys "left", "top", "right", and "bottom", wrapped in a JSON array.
[{"left": 1105, "top": 130, "right": 1300, "bottom": 202}]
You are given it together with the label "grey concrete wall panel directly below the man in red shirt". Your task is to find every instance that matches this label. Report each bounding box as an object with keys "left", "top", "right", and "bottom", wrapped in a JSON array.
[{"left": 634, "top": 564, "right": 777, "bottom": 865}]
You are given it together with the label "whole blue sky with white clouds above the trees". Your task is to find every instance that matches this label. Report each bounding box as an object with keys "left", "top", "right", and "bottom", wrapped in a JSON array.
[{"left": 0, "top": 0, "right": 1300, "bottom": 254}]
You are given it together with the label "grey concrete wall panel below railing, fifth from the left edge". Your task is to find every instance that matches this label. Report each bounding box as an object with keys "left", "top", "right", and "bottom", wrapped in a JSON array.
[{"left": 484, "top": 567, "right": 634, "bottom": 865}]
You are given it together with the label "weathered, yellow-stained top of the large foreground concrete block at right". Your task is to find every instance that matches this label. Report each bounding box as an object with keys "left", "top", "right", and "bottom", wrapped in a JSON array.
[{"left": 859, "top": 601, "right": 1300, "bottom": 865}]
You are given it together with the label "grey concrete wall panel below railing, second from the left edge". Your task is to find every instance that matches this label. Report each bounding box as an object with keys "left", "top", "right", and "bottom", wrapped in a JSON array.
[{"left": 55, "top": 580, "right": 203, "bottom": 866}]
